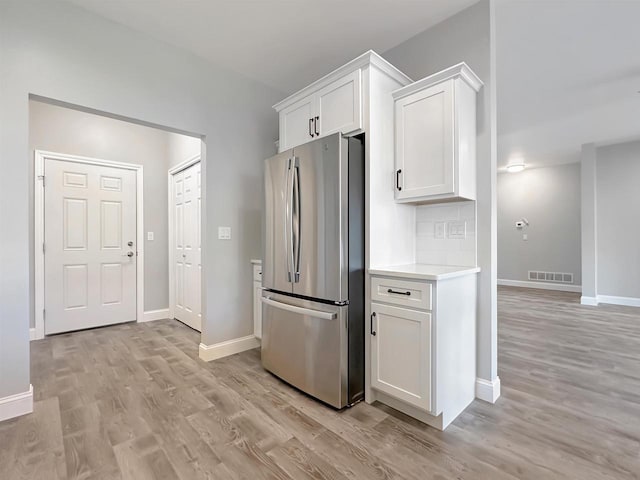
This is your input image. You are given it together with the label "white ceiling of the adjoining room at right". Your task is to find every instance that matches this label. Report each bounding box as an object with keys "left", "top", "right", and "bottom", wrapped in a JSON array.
[{"left": 496, "top": 0, "right": 640, "bottom": 166}]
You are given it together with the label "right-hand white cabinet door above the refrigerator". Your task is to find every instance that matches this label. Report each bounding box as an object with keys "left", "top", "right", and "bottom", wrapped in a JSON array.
[{"left": 316, "top": 69, "right": 362, "bottom": 140}]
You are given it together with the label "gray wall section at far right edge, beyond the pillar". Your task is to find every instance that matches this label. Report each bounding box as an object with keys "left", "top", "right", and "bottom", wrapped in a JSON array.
[{"left": 596, "top": 141, "right": 640, "bottom": 299}]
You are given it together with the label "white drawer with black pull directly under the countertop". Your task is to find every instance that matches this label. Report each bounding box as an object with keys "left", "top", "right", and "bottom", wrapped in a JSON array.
[{"left": 371, "top": 277, "right": 431, "bottom": 310}]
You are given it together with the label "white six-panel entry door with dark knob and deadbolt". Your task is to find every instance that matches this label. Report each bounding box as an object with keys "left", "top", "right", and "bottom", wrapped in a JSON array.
[{"left": 43, "top": 158, "right": 137, "bottom": 334}]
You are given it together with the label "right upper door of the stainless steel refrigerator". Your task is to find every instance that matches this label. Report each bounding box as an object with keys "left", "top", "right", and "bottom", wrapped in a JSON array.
[{"left": 291, "top": 133, "right": 349, "bottom": 301}]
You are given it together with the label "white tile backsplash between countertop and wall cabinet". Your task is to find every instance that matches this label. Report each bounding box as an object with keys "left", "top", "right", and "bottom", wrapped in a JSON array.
[{"left": 416, "top": 201, "right": 477, "bottom": 266}]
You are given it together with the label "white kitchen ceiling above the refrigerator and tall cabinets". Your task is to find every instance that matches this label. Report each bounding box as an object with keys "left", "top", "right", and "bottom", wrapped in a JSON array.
[{"left": 62, "top": 0, "right": 477, "bottom": 94}]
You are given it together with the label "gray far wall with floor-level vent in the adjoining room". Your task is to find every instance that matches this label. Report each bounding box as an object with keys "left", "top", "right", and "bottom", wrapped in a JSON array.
[{"left": 498, "top": 163, "right": 582, "bottom": 285}]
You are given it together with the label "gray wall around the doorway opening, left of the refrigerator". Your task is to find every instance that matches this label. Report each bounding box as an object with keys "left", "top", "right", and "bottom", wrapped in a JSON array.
[{"left": 0, "top": 1, "right": 283, "bottom": 398}]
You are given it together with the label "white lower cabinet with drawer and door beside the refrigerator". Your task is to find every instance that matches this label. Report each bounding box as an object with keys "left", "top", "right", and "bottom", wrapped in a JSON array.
[{"left": 365, "top": 274, "right": 477, "bottom": 430}]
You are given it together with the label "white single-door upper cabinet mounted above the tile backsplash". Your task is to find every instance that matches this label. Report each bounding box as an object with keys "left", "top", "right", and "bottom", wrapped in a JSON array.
[{"left": 393, "top": 63, "right": 482, "bottom": 203}]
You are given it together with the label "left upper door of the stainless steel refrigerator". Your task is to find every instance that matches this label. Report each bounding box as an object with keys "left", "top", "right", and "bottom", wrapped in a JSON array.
[{"left": 262, "top": 150, "right": 293, "bottom": 293}]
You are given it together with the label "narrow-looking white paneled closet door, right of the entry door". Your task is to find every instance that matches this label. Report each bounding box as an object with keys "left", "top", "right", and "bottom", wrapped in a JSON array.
[{"left": 172, "top": 163, "right": 202, "bottom": 331}]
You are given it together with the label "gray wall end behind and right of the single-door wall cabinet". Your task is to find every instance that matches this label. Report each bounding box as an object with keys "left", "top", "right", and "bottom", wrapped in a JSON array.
[{"left": 383, "top": 0, "right": 497, "bottom": 380}]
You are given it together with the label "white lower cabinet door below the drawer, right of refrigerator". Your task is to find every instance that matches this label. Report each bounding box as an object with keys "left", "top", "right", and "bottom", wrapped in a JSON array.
[{"left": 370, "top": 303, "right": 431, "bottom": 412}]
